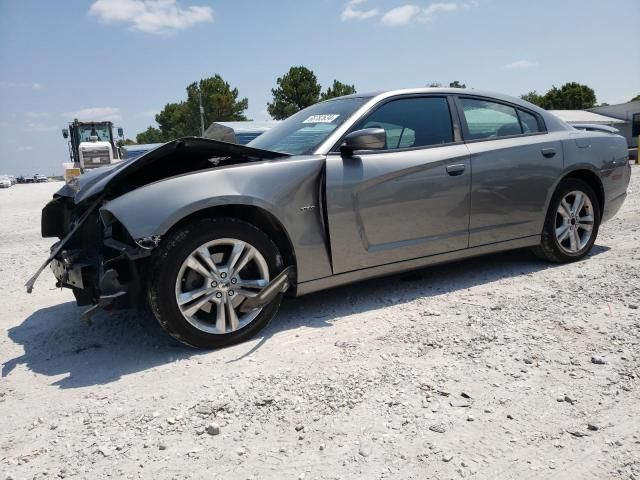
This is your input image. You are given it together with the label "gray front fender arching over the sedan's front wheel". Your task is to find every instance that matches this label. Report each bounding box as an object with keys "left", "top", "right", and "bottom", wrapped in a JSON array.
[{"left": 101, "top": 156, "right": 331, "bottom": 281}]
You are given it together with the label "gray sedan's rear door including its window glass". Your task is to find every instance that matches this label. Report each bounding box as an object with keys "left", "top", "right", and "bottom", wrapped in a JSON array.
[{"left": 458, "top": 96, "right": 563, "bottom": 247}]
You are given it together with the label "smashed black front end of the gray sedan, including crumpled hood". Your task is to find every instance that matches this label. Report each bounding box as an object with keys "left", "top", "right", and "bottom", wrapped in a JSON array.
[{"left": 26, "top": 138, "right": 286, "bottom": 319}]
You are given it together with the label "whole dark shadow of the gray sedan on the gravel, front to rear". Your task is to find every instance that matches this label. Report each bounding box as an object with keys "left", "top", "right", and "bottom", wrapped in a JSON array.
[{"left": 2, "top": 246, "right": 609, "bottom": 388}]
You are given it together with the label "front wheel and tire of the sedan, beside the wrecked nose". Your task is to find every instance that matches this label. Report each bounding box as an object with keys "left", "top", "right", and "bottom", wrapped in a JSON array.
[{"left": 147, "top": 218, "right": 283, "bottom": 349}]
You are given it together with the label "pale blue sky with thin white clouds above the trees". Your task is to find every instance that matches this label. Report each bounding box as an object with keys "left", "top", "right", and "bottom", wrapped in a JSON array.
[{"left": 0, "top": 0, "right": 640, "bottom": 175}]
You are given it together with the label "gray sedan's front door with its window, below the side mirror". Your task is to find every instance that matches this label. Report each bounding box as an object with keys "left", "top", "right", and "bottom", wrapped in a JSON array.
[{"left": 326, "top": 96, "right": 471, "bottom": 273}]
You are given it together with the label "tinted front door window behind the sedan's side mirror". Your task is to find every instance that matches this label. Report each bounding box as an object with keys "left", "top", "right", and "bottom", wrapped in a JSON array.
[{"left": 353, "top": 97, "right": 453, "bottom": 150}]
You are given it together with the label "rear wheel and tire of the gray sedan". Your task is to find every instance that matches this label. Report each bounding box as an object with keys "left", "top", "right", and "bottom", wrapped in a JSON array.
[{"left": 533, "top": 178, "right": 600, "bottom": 263}]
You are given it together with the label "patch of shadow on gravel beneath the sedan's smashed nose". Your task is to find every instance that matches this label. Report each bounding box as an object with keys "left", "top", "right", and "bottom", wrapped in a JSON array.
[{"left": 2, "top": 302, "right": 204, "bottom": 388}]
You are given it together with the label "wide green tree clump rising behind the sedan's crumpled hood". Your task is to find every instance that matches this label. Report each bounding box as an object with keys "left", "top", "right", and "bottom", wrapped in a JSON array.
[{"left": 136, "top": 74, "right": 249, "bottom": 143}]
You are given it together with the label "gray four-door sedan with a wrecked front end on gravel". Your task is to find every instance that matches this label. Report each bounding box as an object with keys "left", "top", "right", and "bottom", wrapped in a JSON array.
[{"left": 33, "top": 88, "right": 631, "bottom": 348}]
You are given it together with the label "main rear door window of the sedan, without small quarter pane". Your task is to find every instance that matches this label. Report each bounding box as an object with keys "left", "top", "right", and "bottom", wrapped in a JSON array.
[{"left": 460, "top": 98, "right": 522, "bottom": 140}]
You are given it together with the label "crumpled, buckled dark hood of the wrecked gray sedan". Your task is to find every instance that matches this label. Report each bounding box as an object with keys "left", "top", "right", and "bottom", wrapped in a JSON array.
[{"left": 56, "top": 137, "right": 289, "bottom": 204}]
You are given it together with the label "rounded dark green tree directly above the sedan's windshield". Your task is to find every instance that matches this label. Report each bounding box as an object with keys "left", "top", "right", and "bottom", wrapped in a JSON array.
[{"left": 267, "top": 66, "right": 321, "bottom": 120}]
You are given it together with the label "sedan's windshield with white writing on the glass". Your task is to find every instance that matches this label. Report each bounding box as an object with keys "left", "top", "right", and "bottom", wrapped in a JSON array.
[{"left": 248, "top": 97, "right": 369, "bottom": 155}]
